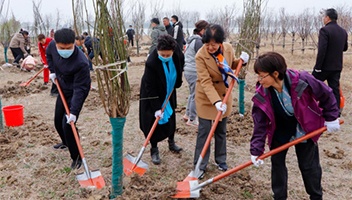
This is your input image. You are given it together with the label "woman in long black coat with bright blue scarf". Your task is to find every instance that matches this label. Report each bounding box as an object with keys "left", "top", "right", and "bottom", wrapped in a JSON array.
[{"left": 139, "top": 34, "right": 184, "bottom": 165}]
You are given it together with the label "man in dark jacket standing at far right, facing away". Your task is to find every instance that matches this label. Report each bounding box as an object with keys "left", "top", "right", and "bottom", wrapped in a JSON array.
[{"left": 312, "top": 8, "right": 348, "bottom": 112}]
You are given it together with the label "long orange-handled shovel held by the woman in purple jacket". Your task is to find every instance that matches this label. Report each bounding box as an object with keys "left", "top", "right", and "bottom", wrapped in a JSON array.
[{"left": 172, "top": 119, "right": 344, "bottom": 199}]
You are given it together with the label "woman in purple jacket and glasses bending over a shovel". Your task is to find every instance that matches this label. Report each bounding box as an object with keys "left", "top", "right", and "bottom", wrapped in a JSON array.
[{"left": 250, "top": 52, "right": 340, "bottom": 200}]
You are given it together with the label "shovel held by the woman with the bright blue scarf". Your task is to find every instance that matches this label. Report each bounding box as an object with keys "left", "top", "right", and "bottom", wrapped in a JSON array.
[{"left": 123, "top": 91, "right": 173, "bottom": 176}]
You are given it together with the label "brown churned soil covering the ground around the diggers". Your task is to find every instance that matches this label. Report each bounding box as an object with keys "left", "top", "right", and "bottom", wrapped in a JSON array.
[{"left": 0, "top": 39, "right": 352, "bottom": 200}]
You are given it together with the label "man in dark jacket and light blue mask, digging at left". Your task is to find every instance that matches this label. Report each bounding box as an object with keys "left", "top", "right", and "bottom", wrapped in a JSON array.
[{"left": 46, "top": 28, "right": 91, "bottom": 169}]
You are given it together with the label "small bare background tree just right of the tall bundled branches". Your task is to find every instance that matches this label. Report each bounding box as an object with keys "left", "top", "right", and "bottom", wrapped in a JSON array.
[{"left": 131, "top": 0, "right": 146, "bottom": 56}]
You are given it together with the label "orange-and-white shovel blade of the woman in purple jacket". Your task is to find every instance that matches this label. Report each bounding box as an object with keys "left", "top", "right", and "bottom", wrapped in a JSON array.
[{"left": 171, "top": 180, "right": 201, "bottom": 199}]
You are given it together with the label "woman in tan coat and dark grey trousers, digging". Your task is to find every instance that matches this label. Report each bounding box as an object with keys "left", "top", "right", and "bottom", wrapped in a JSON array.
[{"left": 194, "top": 24, "right": 249, "bottom": 179}]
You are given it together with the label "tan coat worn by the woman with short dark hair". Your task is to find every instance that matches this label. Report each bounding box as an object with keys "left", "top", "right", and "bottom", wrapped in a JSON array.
[{"left": 195, "top": 43, "right": 239, "bottom": 120}]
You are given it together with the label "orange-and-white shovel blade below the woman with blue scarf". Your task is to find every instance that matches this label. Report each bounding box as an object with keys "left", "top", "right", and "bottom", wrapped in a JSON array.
[{"left": 123, "top": 154, "right": 148, "bottom": 176}]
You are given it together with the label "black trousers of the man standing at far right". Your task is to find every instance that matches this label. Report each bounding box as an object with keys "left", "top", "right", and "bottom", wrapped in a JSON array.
[{"left": 312, "top": 71, "right": 341, "bottom": 108}]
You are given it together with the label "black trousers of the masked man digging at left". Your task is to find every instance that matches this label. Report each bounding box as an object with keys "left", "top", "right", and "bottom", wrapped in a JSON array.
[{"left": 54, "top": 95, "right": 79, "bottom": 160}]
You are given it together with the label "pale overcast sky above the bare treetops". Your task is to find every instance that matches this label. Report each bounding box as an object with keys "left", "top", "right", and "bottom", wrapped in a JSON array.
[{"left": 1, "top": 0, "right": 352, "bottom": 22}]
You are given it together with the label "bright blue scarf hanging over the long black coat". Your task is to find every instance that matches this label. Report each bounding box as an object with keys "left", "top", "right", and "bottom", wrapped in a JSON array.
[{"left": 158, "top": 55, "right": 177, "bottom": 124}]
